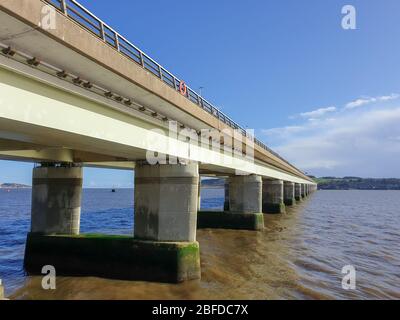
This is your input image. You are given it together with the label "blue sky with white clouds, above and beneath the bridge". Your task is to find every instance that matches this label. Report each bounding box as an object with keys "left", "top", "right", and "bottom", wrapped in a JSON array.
[{"left": 0, "top": 0, "right": 400, "bottom": 186}]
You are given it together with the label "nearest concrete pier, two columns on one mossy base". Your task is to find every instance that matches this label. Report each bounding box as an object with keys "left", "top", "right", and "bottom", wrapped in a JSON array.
[{"left": 24, "top": 164, "right": 201, "bottom": 283}]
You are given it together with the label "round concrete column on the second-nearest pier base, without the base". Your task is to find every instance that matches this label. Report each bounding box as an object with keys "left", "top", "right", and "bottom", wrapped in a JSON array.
[{"left": 229, "top": 175, "right": 262, "bottom": 214}]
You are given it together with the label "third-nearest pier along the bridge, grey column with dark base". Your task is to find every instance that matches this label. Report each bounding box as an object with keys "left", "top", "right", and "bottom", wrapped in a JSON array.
[{"left": 262, "top": 179, "right": 286, "bottom": 213}]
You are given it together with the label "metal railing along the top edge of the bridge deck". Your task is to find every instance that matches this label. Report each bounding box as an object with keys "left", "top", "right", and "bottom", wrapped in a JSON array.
[{"left": 44, "top": 0, "right": 298, "bottom": 170}]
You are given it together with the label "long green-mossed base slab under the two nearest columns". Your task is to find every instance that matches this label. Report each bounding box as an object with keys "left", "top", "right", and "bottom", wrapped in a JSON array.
[{"left": 24, "top": 233, "right": 201, "bottom": 283}]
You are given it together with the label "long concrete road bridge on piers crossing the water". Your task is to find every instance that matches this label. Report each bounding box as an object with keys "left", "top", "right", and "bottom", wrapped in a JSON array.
[{"left": 0, "top": 0, "right": 316, "bottom": 282}]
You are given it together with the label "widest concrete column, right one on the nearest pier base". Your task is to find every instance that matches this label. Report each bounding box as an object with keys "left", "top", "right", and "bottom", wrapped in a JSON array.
[{"left": 134, "top": 164, "right": 199, "bottom": 242}]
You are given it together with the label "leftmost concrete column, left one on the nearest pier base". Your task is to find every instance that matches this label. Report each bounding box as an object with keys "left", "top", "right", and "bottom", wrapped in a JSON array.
[{"left": 31, "top": 166, "right": 82, "bottom": 234}]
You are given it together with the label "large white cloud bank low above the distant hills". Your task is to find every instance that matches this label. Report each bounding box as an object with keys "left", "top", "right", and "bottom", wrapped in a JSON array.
[{"left": 264, "top": 105, "right": 400, "bottom": 177}]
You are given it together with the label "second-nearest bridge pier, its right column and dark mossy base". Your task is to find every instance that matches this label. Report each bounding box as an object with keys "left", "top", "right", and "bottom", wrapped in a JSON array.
[{"left": 198, "top": 175, "right": 264, "bottom": 230}]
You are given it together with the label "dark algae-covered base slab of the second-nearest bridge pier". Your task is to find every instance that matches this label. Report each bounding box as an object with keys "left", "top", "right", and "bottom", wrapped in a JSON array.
[{"left": 197, "top": 211, "right": 264, "bottom": 231}]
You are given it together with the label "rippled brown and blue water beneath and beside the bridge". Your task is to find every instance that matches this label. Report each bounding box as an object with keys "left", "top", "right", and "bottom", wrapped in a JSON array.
[{"left": 0, "top": 189, "right": 400, "bottom": 299}]
